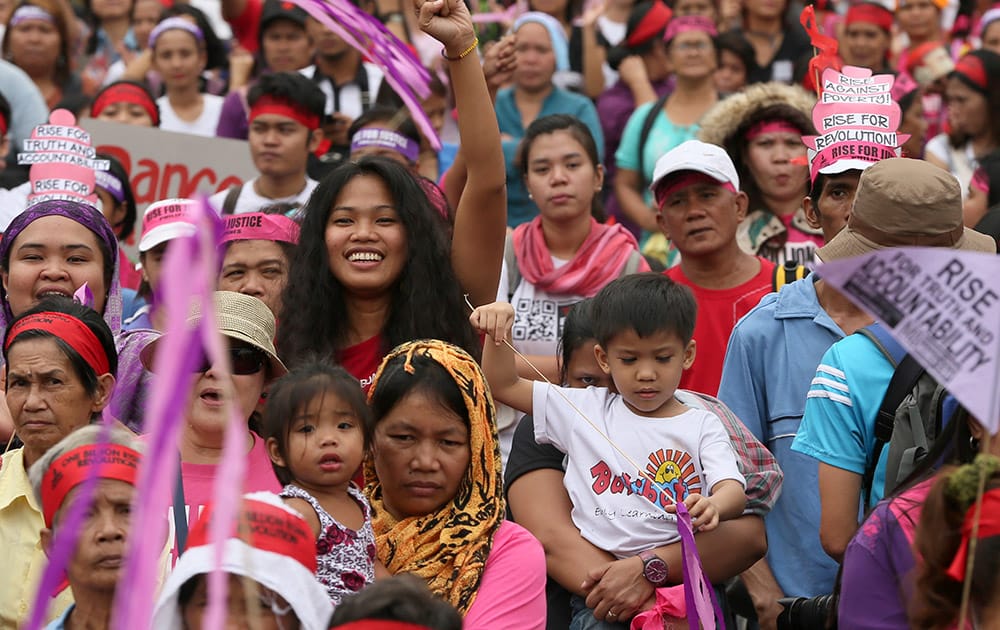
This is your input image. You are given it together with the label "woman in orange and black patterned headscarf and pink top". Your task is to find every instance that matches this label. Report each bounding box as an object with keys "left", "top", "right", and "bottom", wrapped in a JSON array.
[{"left": 365, "top": 341, "right": 545, "bottom": 630}]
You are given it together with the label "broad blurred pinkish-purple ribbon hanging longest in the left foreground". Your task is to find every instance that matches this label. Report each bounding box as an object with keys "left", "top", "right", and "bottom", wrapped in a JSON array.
[{"left": 112, "top": 200, "right": 222, "bottom": 630}]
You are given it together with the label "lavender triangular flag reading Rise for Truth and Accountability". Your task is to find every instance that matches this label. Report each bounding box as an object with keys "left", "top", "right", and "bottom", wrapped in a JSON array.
[{"left": 816, "top": 247, "right": 1000, "bottom": 433}]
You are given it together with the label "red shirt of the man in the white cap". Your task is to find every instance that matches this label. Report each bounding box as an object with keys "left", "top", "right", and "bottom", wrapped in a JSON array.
[{"left": 664, "top": 257, "right": 774, "bottom": 396}]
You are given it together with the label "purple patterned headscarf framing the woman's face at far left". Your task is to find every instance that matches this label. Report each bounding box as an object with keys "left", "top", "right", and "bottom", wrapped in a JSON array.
[{"left": 0, "top": 200, "right": 122, "bottom": 337}]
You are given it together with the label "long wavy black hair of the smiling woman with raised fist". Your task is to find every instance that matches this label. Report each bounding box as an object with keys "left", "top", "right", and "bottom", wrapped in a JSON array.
[{"left": 277, "top": 157, "right": 481, "bottom": 367}]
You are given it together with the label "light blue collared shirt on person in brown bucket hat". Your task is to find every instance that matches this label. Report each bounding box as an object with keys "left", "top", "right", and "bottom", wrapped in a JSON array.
[{"left": 719, "top": 277, "right": 844, "bottom": 597}]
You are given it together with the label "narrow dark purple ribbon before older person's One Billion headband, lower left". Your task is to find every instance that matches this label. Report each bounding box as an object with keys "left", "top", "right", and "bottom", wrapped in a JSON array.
[{"left": 22, "top": 407, "right": 115, "bottom": 630}]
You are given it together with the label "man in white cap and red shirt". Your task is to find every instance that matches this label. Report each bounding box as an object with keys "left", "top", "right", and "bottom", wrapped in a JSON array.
[{"left": 650, "top": 140, "right": 774, "bottom": 396}]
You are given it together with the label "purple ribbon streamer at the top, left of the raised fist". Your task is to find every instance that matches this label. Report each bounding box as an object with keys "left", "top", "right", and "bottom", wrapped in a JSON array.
[{"left": 282, "top": 0, "right": 441, "bottom": 151}]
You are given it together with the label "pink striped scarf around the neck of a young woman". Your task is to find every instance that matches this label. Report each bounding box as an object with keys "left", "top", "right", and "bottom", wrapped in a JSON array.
[{"left": 514, "top": 217, "right": 649, "bottom": 298}]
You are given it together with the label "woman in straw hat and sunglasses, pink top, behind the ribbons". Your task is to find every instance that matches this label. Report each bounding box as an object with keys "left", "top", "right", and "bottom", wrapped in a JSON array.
[{"left": 142, "top": 291, "right": 286, "bottom": 558}]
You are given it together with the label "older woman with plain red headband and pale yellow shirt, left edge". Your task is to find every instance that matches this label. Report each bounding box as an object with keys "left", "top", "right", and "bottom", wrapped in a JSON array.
[{"left": 0, "top": 297, "right": 118, "bottom": 628}]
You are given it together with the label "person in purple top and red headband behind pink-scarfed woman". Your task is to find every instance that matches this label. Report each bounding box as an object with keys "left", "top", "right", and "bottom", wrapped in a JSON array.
[{"left": 597, "top": 0, "right": 673, "bottom": 236}]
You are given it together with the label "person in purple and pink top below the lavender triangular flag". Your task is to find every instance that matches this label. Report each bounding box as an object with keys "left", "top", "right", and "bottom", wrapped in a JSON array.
[{"left": 837, "top": 410, "right": 984, "bottom": 630}]
